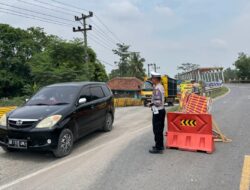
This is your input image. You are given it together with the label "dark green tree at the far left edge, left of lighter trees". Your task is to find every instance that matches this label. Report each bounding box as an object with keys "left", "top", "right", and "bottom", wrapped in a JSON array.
[{"left": 0, "top": 24, "right": 33, "bottom": 97}]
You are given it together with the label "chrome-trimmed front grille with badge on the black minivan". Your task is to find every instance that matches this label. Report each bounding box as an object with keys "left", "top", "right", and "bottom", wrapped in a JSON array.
[{"left": 8, "top": 118, "right": 38, "bottom": 128}]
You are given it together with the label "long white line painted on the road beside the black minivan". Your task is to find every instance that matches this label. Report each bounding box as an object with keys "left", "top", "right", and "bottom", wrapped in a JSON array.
[{"left": 0, "top": 125, "right": 151, "bottom": 190}]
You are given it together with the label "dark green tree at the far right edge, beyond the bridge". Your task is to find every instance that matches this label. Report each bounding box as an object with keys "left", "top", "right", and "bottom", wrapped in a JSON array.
[{"left": 234, "top": 53, "right": 250, "bottom": 79}]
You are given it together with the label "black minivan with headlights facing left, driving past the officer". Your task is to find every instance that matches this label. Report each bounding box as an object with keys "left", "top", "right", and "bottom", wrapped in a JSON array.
[{"left": 0, "top": 82, "right": 115, "bottom": 157}]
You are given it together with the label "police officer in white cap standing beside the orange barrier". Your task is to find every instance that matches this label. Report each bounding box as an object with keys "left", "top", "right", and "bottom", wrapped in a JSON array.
[{"left": 149, "top": 72, "right": 166, "bottom": 154}]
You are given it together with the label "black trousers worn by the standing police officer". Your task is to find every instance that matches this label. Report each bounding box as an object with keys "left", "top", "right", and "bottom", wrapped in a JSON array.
[{"left": 153, "top": 109, "right": 166, "bottom": 148}]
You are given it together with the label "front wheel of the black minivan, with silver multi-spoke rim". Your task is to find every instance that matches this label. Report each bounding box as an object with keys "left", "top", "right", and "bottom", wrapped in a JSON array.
[{"left": 53, "top": 129, "right": 74, "bottom": 158}]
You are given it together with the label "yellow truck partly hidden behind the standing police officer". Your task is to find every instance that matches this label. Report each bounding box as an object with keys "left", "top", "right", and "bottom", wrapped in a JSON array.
[{"left": 141, "top": 75, "right": 177, "bottom": 106}]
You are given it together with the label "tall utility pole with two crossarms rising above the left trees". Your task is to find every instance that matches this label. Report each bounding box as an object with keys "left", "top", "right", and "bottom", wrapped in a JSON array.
[{"left": 73, "top": 11, "right": 93, "bottom": 62}]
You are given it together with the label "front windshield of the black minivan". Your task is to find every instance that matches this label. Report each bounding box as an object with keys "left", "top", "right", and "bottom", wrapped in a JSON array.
[{"left": 27, "top": 86, "right": 78, "bottom": 105}]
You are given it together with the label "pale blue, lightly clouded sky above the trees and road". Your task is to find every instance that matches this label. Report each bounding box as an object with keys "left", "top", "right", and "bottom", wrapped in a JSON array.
[{"left": 0, "top": 0, "right": 250, "bottom": 76}]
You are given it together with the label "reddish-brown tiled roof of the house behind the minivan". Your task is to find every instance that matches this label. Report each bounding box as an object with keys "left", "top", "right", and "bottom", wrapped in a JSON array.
[{"left": 107, "top": 77, "right": 143, "bottom": 91}]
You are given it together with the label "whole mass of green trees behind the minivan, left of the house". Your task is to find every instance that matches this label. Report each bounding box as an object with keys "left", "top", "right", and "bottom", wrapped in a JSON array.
[{"left": 0, "top": 24, "right": 108, "bottom": 98}]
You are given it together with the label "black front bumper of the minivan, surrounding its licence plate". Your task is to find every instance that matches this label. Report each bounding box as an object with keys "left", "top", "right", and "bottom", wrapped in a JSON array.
[{"left": 0, "top": 126, "right": 59, "bottom": 150}]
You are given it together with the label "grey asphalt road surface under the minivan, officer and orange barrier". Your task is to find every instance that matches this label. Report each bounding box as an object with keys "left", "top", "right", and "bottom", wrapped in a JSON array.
[{"left": 0, "top": 85, "right": 250, "bottom": 190}]
